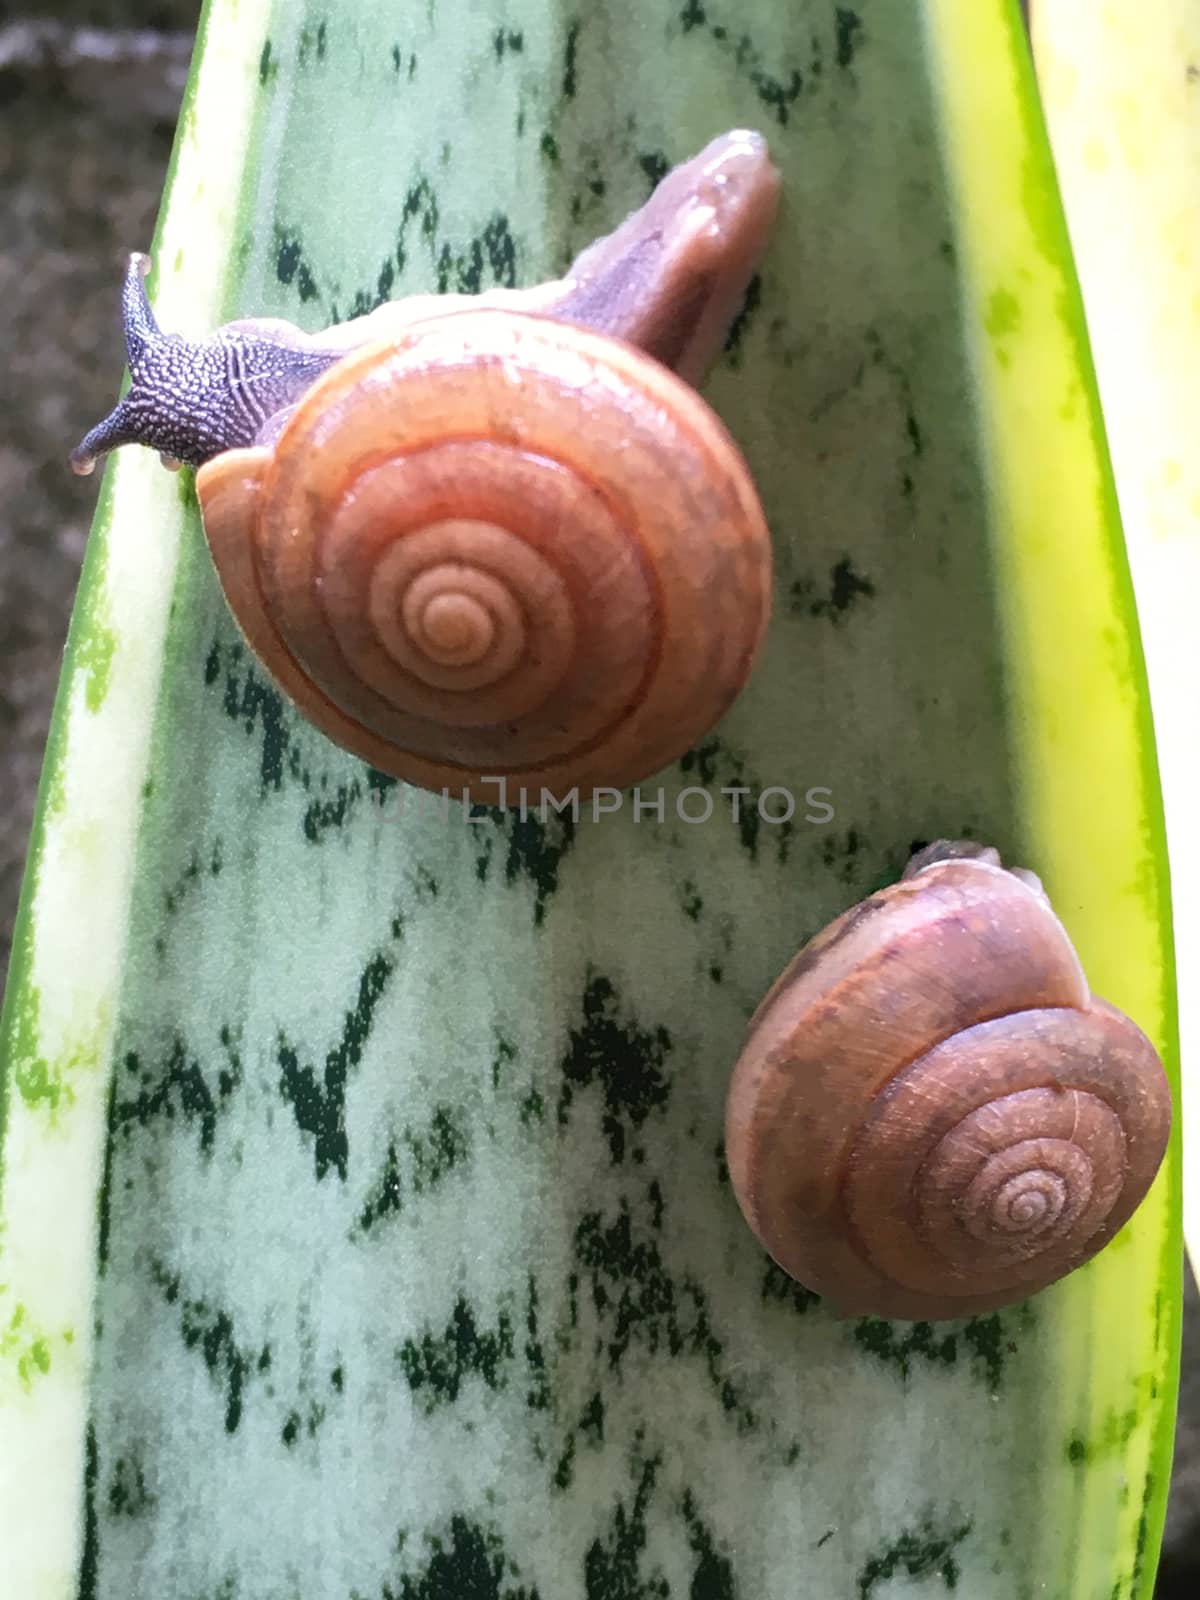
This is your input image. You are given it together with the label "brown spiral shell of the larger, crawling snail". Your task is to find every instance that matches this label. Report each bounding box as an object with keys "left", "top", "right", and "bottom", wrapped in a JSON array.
[{"left": 197, "top": 309, "right": 771, "bottom": 803}]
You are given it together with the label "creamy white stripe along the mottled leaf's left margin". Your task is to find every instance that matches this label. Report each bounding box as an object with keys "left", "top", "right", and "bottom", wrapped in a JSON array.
[{"left": 0, "top": 3, "right": 264, "bottom": 1600}]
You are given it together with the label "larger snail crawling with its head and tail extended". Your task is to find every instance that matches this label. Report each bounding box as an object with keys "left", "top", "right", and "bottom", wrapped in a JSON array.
[{"left": 72, "top": 131, "right": 779, "bottom": 803}]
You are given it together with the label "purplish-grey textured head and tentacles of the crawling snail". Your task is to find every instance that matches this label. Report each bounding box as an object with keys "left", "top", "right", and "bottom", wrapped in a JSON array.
[{"left": 70, "top": 254, "right": 338, "bottom": 474}]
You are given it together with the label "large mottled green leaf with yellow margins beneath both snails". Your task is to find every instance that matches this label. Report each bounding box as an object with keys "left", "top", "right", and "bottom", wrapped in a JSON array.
[{"left": 0, "top": 0, "right": 1179, "bottom": 1600}]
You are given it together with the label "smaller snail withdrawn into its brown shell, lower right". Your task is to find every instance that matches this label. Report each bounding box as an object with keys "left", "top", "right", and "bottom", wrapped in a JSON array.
[{"left": 725, "top": 842, "right": 1171, "bottom": 1320}]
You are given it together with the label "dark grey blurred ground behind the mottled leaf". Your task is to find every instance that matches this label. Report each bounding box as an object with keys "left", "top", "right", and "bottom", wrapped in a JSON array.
[{"left": 0, "top": 0, "right": 1200, "bottom": 1600}]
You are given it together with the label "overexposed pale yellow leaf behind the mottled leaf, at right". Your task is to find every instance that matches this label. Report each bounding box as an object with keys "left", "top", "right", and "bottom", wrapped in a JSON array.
[{"left": 1034, "top": 0, "right": 1200, "bottom": 1262}]
